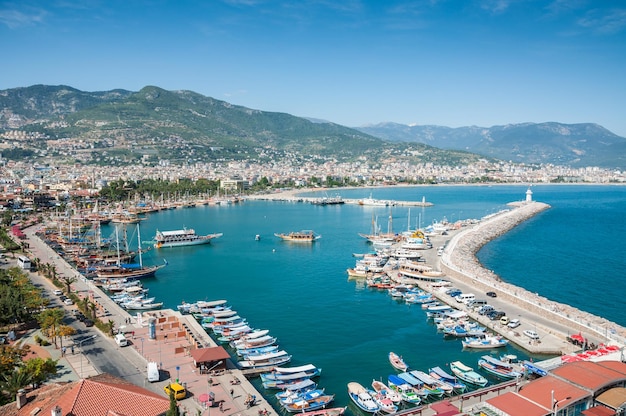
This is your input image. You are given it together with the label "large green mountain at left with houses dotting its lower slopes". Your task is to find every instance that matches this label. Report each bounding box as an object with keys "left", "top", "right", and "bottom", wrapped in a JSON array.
[{"left": 0, "top": 85, "right": 479, "bottom": 165}]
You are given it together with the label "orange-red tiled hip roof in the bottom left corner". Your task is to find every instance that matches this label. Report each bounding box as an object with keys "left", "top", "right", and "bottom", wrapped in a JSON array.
[{"left": 0, "top": 374, "right": 170, "bottom": 416}]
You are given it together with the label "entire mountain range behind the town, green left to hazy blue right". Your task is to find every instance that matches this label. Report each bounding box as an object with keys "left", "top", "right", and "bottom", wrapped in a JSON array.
[{"left": 0, "top": 85, "right": 626, "bottom": 169}]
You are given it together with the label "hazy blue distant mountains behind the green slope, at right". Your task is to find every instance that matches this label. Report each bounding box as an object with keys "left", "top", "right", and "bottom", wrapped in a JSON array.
[{"left": 356, "top": 122, "right": 626, "bottom": 169}]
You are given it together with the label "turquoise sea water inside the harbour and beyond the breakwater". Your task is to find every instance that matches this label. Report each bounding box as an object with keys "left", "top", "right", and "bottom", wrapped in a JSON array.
[{"left": 100, "top": 185, "right": 626, "bottom": 412}]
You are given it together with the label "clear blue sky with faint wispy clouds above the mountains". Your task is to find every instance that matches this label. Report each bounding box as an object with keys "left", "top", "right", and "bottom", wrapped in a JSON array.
[{"left": 0, "top": 0, "right": 626, "bottom": 137}]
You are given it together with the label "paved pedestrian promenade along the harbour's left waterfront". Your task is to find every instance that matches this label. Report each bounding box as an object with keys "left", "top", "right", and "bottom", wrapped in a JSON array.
[{"left": 23, "top": 225, "right": 277, "bottom": 416}]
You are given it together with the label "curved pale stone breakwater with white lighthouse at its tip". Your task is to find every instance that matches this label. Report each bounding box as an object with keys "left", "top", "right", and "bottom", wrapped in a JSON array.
[{"left": 440, "top": 202, "right": 626, "bottom": 345}]
